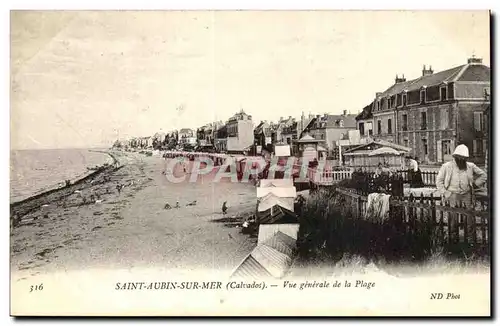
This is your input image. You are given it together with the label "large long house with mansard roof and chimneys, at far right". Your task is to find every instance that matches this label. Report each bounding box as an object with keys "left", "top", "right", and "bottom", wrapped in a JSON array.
[{"left": 357, "top": 58, "right": 490, "bottom": 164}]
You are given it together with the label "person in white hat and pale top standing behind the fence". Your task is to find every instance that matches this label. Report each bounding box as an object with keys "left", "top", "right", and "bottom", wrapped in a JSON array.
[{"left": 436, "top": 145, "right": 487, "bottom": 242}]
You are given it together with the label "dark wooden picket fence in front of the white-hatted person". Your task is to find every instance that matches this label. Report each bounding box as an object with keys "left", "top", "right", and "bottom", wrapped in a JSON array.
[{"left": 335, "top": 188, "right": 491, "bottom": 254}]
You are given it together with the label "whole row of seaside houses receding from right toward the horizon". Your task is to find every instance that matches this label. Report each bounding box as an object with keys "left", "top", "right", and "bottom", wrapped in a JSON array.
[{"left": 114, "top": 57, "right": 490, "bottom": 164}]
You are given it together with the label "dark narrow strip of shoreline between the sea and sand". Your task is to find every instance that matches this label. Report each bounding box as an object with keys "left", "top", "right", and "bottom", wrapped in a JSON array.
[{"left": 10, "top": 150, "right": 123, "bottom": 220}]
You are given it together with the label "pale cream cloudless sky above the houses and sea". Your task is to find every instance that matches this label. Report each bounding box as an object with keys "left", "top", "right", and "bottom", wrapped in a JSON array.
[{"left": 10, "top": 11, "right": 490, "bottom": 149}]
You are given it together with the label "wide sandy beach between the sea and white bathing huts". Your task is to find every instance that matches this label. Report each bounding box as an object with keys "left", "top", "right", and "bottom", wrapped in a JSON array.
[{"left": 11, "top": 152, "right": 256, "bottom": 282}]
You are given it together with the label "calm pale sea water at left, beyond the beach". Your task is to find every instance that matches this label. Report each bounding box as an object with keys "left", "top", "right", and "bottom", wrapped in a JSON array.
[{"left": 10, "top": 149, "right": 112, "bottom": 203}]
